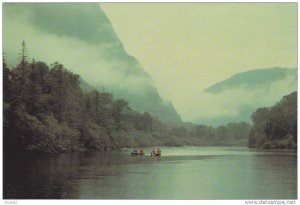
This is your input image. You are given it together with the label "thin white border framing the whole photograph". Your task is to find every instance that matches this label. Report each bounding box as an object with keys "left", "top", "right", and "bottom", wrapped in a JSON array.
[{"left": 0, "top": 0, "right": 300, "bottom": 205}]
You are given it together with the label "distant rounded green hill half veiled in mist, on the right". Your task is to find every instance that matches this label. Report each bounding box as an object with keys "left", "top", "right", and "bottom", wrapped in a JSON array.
[{"left": 197, "top": 67, "right": 297, "bottom": 126}]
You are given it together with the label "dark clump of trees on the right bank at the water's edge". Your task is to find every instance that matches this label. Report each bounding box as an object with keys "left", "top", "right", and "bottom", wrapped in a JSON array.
[{"left": 249, "top": 91, "right": 297, "bottom": 149}]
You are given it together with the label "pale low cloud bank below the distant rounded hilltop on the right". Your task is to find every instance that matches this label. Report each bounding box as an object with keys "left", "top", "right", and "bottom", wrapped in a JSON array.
[{"left": 182, "top": 74, "right": 297, "bottom": 125}]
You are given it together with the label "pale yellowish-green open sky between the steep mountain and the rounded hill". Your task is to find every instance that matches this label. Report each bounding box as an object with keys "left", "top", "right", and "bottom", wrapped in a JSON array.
[{"left": 101, "top": 3, "right": 297, "bottom": 121}]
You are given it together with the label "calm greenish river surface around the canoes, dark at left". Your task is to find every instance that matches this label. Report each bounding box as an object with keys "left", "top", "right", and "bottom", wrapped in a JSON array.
[{"left": 4, "top": 147, "right": 297, "bottom": 199}]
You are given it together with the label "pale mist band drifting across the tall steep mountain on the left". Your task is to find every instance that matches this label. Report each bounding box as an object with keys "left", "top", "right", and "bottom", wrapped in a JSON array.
[{"left": 3, "top": 3, "right": 152, "bottom": 95}]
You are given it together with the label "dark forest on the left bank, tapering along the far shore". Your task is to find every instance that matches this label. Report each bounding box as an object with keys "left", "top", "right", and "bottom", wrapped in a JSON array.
[{"left": 3, "top": 42, "right": 251, "bottom": 153}]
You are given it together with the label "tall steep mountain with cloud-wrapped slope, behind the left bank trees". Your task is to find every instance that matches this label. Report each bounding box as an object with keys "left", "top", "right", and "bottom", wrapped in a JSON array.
[{"left": 3, "top": 3, "right": 181, "bottom": 124}]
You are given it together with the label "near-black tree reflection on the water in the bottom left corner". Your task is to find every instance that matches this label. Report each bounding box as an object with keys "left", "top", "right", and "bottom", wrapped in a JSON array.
[{"left": 4, "top": 154, "right": 78, "bottom": 199}]
